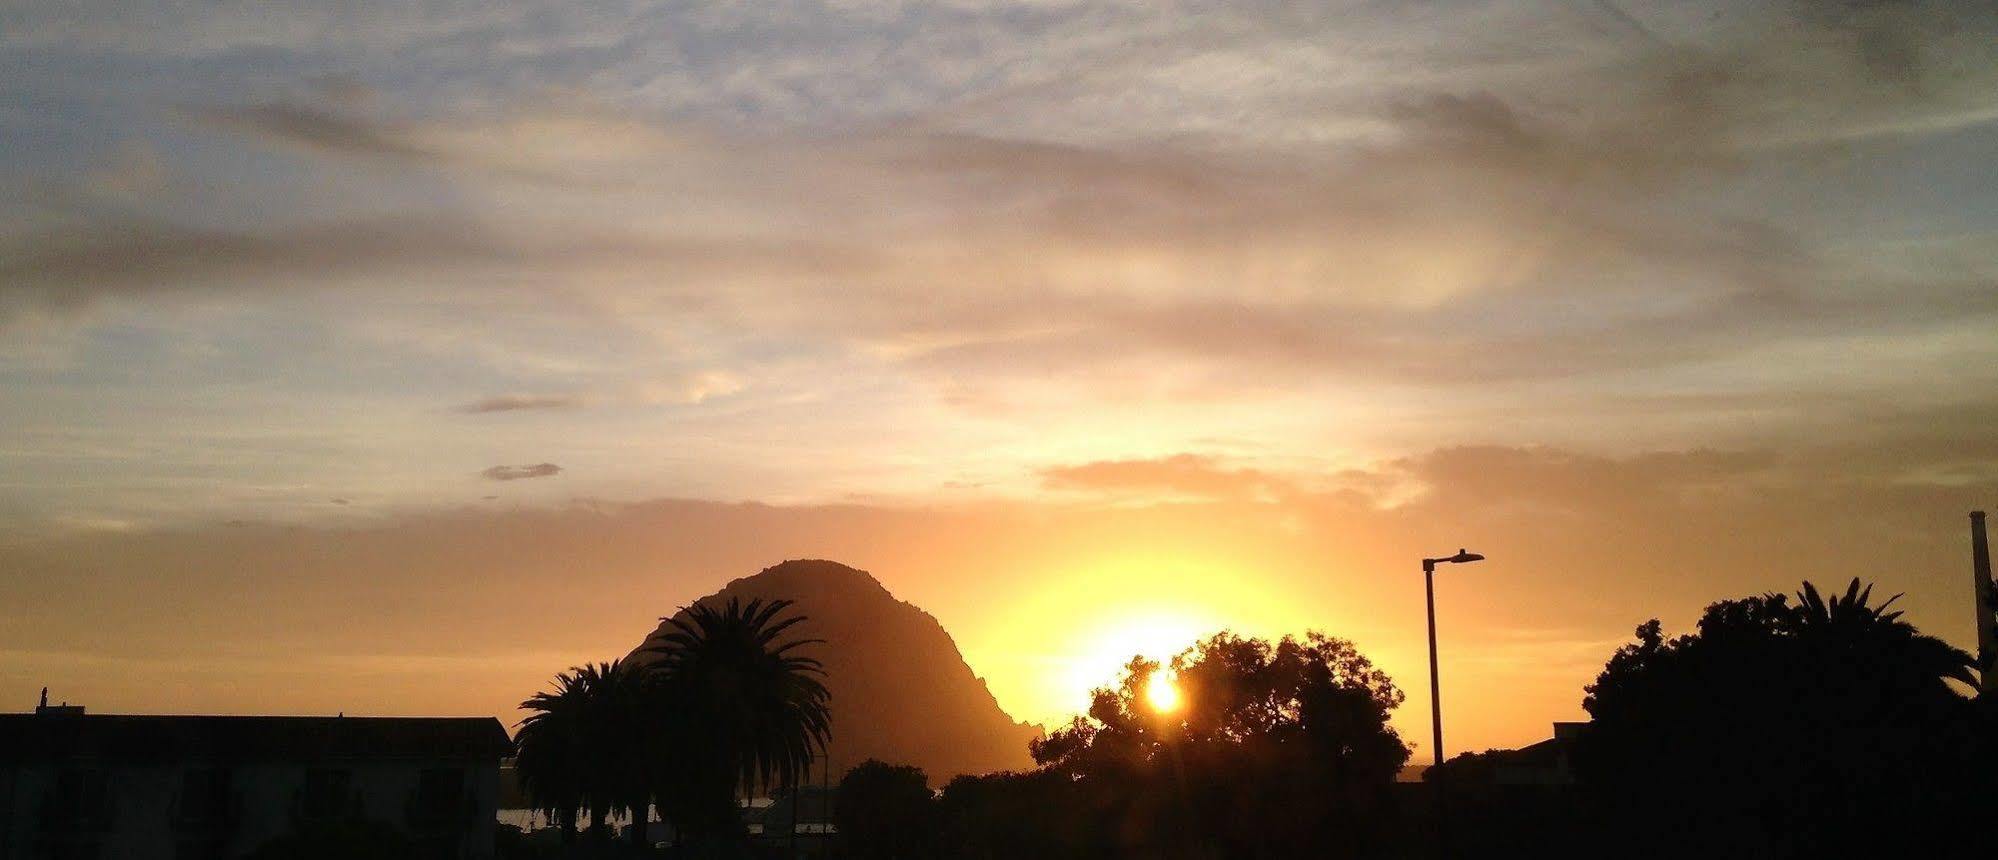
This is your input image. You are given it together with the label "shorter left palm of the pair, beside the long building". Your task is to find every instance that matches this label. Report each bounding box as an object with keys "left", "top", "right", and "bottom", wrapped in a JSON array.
[{"left": 513, "top": 660, "right": 649, "bottom": 842}]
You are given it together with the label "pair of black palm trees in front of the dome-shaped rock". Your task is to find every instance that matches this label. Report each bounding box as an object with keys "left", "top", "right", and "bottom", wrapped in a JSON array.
[{"left": 513, "top": 600, "right": 831, "bottom": 854}]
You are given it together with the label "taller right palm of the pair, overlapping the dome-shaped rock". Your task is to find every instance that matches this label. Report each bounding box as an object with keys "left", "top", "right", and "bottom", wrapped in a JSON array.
[{"left": 647, "top": 598, "right": 831, "bottom": 838}]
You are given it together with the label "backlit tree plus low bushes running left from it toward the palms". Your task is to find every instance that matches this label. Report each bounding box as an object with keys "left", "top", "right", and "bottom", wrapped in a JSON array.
[{"left": 839, "top": 634, "right": 1409, "bottom": 860}]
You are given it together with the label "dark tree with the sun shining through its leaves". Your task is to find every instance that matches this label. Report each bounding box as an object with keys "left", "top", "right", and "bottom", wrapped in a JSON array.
[{"left": 999, "top": 634, "right": 1409, "bottom": 858}]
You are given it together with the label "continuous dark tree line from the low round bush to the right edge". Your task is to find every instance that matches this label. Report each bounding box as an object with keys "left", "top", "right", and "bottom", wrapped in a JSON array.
[{"left": 839, "top": 580, "right": 1998, "bottom": 860}]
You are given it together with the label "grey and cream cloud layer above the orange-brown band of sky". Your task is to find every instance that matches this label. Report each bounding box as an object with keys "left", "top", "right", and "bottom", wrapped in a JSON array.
[{"left": 0, "top": 0, "right": 1998, "bottom": 528}]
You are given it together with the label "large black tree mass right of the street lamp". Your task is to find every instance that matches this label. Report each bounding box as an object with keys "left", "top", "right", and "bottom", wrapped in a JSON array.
[{"left": 1576, "top": 580, "right": 1990, "bottom": 856}]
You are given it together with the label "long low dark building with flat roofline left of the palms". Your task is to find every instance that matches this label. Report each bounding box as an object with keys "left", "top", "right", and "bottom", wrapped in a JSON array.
[{"left": 0, "top": 698, "right": 511, "bottom": 860}]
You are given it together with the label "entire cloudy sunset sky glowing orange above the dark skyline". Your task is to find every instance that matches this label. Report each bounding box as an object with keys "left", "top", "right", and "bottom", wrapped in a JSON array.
[{"left": 0, "top": 0, "right": 1998, "bottom": 758}]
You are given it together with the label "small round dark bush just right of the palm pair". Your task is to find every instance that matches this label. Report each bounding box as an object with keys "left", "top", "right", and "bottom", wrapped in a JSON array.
[{"left": 833, "top": 758, "right": 937, "bottom": 860}]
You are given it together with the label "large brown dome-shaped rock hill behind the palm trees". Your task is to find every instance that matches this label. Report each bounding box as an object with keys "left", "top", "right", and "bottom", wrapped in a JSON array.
[{"left": 629, "top": 560, "right": 1039, "bottom": 784}]
